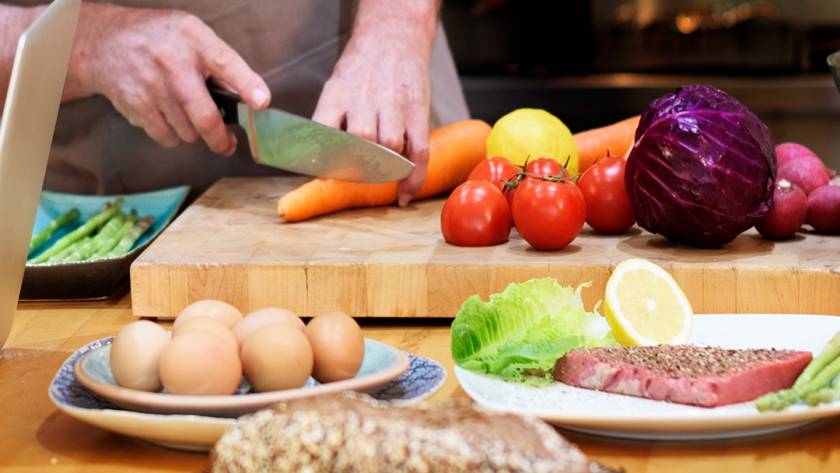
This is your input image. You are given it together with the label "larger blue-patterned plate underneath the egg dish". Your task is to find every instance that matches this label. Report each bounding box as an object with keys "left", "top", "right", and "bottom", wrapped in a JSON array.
[{"left": 49, "top": 338, "right": 446, "bottom": 450}]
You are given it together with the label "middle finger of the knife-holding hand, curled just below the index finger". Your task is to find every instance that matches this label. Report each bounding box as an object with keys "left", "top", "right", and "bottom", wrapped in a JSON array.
[{"left": 172, "top": 73, "right": 236, "bottom": 156}]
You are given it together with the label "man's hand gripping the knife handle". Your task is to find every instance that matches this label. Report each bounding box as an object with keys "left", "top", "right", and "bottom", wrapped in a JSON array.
[{"left": 65, "top": 4, "right": 271, "bottom": 155}]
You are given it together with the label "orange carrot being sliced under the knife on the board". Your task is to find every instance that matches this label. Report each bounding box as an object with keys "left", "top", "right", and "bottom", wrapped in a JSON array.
[{"left": 277, "top": 120, "right": 490, "bottom": 222}]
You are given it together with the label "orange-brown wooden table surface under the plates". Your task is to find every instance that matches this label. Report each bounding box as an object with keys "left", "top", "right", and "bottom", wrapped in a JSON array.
[{"left": 0, "top": 297, "right": 840, "bottom": 473}]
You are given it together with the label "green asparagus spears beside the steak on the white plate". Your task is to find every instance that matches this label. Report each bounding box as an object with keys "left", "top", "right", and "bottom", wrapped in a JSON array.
[{"left": 755, "top": 332, "right": 840, "bottom": 411}]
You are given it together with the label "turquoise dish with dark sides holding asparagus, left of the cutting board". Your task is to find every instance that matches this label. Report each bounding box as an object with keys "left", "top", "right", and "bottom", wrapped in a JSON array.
[{"left": 20, "top": 186, "right": 189, "bottom": 300}]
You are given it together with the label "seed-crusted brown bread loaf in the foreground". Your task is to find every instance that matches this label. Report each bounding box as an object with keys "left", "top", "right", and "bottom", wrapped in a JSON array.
[{"left": 211, "top": 393, "right": 615, "bottom": 473}]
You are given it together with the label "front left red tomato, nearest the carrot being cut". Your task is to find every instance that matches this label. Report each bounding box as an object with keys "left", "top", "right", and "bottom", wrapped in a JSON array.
[{"left": 440, "top": 181, "right": 512, "bottom": 246}]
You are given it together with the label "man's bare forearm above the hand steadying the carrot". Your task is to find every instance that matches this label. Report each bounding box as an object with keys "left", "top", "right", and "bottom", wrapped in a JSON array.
[{"left": 353, "top": 0, "right": 440, "bottom": 58}]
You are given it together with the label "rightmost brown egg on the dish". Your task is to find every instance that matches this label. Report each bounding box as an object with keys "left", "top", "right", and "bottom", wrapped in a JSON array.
[{"left": 304, "top": 311, "right": 365, "bottom": 383}]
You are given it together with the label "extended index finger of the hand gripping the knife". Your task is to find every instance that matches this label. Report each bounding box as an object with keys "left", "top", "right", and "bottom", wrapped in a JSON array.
[{"left": 191, "top": 25, "right": 271, "bottom": 109}]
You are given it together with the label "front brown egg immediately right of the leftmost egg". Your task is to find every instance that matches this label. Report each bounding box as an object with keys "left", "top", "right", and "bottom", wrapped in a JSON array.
[{"left": 159, "top": 332, "right": 242, "bottom": 396}]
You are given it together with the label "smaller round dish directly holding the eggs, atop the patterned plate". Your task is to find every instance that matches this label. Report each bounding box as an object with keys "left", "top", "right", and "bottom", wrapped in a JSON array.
[{"left": 75, "top": 338, "right": 410, "bottom": 417}]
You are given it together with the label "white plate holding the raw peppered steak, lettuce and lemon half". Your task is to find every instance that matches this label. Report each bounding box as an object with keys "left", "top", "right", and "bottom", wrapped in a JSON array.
[{"left": 455, "top": 314, "right": 840, "bottom": 440}]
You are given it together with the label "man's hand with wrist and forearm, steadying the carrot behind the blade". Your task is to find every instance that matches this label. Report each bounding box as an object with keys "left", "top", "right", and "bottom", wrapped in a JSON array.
[{"left": 312, "top": 0, "right": 437, "bottom": 205}]
